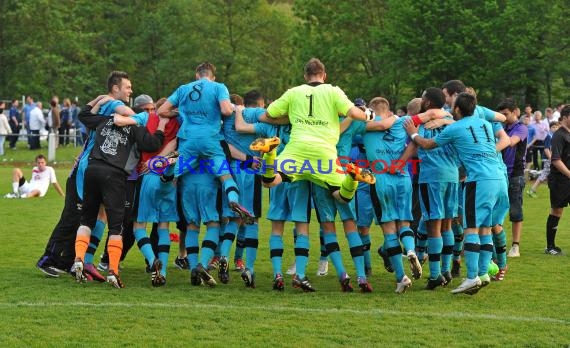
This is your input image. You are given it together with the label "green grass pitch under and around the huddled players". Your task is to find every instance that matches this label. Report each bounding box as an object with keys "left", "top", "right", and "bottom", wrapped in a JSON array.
[{"left": 0, "top": 160, "right": 570, "bottom": 347}]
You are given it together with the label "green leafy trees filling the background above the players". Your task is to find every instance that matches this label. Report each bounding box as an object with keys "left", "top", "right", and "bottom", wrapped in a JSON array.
[{"left": 0, "top": 0, "right": 570, "bottom": 108}]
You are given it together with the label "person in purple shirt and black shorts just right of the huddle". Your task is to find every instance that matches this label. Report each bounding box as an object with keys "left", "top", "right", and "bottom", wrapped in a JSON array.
[{"left": 497, "top": 98, "right": 528, "bottom": 257}]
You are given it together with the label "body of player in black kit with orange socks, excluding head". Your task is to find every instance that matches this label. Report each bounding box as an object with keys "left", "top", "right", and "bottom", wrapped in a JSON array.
[{"left": 73, "top": 98, "right": 168, "bottom": 288}]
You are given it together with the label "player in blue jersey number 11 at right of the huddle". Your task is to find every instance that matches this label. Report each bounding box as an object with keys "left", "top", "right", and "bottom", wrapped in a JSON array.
[{"left": 405, "top": 93, "right": 504, "bottom": 294}]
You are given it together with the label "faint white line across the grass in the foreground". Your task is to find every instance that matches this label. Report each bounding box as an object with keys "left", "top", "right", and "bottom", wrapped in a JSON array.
[{"left": 0, "top": 302, "right": 570, "bottom": 325}]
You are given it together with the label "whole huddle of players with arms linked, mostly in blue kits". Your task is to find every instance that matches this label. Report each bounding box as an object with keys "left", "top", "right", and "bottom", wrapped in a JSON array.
[{"left": 38, "top": 58, "right": 568, "bottom": 295}]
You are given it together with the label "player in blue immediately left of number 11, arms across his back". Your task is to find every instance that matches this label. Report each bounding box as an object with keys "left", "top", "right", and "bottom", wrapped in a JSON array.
[{"left": 401, "top": 87, "right": 459, "bottom": 290}]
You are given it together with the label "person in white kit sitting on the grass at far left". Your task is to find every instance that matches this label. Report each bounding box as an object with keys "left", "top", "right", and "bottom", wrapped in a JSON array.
[{"left": 4, "top": 155, "right": 65, "bottom": 198}]
